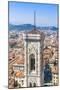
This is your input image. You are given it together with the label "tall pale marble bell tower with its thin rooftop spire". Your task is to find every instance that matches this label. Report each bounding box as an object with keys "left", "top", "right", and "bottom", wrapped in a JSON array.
[{"left": 24, "top": 12, "right": 43, "bottom": 87}]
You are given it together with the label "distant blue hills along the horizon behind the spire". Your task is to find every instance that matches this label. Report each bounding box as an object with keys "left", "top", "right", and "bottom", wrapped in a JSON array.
[{"left": 8, "top": 24, "right": 58, "bottom": 31}]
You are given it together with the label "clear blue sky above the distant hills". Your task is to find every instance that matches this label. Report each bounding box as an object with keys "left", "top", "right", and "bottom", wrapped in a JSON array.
[{"left": 9, "top": 2, "right": 58, "bottom": 26}]
